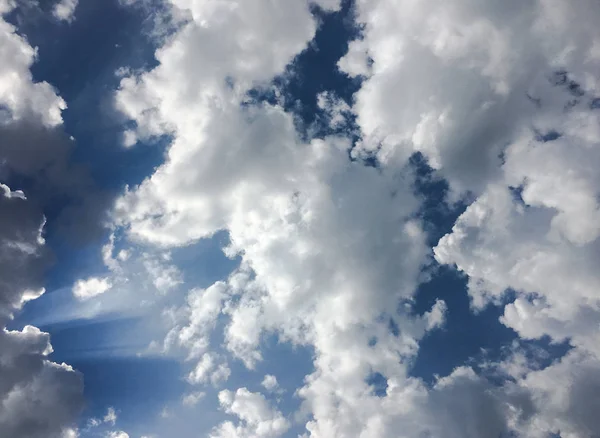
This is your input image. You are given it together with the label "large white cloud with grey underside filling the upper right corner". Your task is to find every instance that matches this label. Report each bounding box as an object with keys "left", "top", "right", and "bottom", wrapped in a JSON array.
[{"left": 340, "top": 0, "right": 598, "bottom": 193}]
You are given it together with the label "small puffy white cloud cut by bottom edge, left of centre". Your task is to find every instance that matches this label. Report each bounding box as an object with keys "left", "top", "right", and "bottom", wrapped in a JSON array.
[{"left": 210, "top": 388, "right": 290, "bottom": 438}]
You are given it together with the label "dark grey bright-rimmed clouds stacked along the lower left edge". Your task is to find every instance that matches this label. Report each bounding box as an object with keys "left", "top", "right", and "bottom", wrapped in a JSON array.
[{"left": 0, "top": 166, "right": 83, "bottom": 438}]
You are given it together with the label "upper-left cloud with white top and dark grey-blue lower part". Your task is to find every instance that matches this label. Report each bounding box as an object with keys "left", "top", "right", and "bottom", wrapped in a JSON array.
[{"left": 0, "top": 2, "right": 110, "bottom": 242}]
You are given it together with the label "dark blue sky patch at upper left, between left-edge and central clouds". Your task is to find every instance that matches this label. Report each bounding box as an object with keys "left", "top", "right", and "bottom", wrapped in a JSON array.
[{"left": 11, "top": 0, "right": 167, "bottom": 191}]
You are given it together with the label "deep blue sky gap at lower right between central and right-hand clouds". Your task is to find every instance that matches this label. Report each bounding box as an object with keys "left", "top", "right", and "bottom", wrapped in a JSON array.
[{"left": 410, "top": 154, "right": 570, "bottom": 384}]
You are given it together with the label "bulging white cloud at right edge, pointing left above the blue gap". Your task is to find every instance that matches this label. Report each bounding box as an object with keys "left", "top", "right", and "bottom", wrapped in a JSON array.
[{"left": 435, "top": 90, "right": 600, "bottom": 354}]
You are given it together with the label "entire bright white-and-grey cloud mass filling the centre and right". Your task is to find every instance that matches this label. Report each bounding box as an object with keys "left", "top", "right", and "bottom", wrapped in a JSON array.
[{"left": 105, "top": 0, "right": 600, "bottom": 438}]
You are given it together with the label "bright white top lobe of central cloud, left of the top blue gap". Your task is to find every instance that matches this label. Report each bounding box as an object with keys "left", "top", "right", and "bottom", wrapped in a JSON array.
[{"left": 116, "top": 0, "right": 339, "bottom": 145}]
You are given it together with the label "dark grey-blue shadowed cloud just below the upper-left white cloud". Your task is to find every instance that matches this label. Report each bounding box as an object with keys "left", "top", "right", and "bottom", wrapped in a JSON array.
[{"left": 0, "top": 117, "right": 111, "bottom": 243}]
